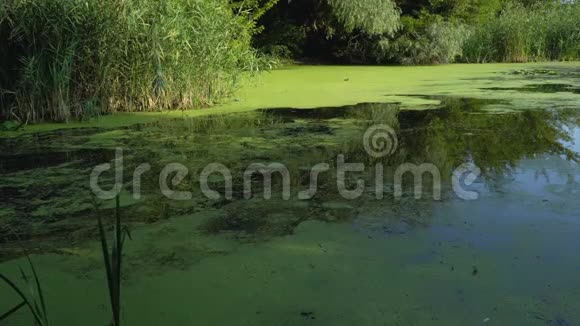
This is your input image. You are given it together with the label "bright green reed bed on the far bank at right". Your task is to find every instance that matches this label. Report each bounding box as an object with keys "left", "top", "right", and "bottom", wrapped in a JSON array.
[{"left": 464, "top": 2, "right": 580, "bottom": 62}]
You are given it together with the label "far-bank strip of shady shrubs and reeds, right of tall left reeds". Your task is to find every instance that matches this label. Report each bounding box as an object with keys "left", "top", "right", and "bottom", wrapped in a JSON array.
[{"left": 255, "top": 0, "right": 580, "bottom": 64}]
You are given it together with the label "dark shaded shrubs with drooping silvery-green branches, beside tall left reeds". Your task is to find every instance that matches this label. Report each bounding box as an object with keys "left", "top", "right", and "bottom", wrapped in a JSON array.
[{"left": 256, "top": 0, "right": 400, "bottom": 62}]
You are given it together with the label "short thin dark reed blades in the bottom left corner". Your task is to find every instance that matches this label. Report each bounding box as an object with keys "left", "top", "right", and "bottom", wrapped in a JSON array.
[{"left": 0, "top": 256, "right": 49, "bottom": 326}]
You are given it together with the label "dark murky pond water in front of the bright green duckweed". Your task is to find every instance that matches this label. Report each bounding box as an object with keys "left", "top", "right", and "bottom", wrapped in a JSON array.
[{"left": 0, "top": 64, "right": 580, "bottom": 325}]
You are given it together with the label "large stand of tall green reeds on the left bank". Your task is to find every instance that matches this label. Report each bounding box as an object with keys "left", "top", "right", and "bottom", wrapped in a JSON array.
[{"left": 0, "top": 0, "right": 257, "bottom": 121}]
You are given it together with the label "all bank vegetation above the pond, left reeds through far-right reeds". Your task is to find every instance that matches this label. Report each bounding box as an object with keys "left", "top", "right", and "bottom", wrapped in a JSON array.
[{"left": 0, "top": 0, "right": 580, "bottom": 123}]
